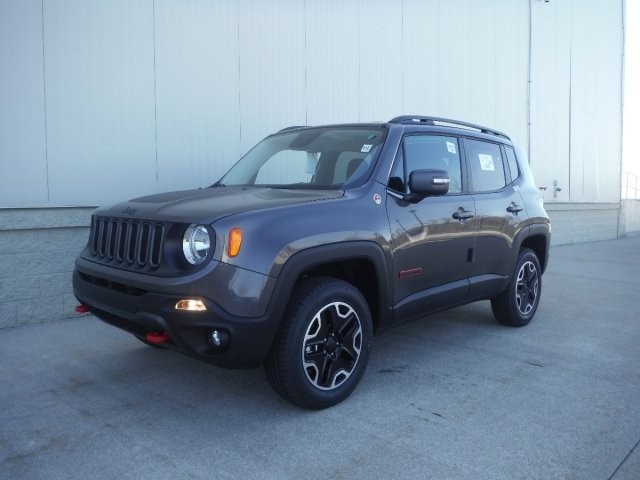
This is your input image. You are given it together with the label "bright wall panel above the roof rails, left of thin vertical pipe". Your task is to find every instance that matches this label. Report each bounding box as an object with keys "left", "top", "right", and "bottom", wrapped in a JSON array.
[{"left": 402, "top": 0, "right": 528, "bottom": 142}]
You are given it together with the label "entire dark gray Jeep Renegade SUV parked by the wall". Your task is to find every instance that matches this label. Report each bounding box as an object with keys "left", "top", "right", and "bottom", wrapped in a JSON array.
[{"left": 73, "top": 116, "right": 550, "bottom": 408}]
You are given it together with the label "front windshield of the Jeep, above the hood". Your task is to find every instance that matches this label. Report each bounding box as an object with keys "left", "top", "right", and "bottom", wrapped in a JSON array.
[{"left": 216, "top": 127, "right": 387, "bottom": 188}]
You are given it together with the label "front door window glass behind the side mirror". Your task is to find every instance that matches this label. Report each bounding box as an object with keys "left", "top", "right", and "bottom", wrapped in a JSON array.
[{"left": 389, "top": 135, "right": 462, "bottom": 194}]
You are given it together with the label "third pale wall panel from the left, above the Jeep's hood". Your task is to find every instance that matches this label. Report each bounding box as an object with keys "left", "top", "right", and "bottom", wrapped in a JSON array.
[{"left": 155, "top": 0, "right": 240, "bottom": 191}]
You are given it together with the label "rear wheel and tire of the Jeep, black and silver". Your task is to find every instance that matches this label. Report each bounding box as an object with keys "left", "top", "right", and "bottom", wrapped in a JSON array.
[{"left": 491, "top": 248, "right": 542, "bottom": 327}]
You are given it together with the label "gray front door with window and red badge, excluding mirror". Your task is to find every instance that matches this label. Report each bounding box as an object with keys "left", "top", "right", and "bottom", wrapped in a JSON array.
[{"left": 386, "top": 134, "right": 478, "bottom": 318}]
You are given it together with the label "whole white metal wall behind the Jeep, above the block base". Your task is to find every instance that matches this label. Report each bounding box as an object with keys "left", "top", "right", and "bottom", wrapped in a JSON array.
[{"left": 0, "top": 0, "right": 622, "bottom": 207}]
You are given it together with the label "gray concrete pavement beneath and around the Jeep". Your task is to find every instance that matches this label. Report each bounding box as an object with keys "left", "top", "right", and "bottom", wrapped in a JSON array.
[{"left": 0, "top": 237, "right": 640, "bottom": 480}]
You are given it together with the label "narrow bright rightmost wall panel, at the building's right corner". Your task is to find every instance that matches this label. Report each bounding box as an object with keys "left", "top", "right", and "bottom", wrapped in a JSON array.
[{"left": 570, "top": 0, "right": 622, "bottom": 202}]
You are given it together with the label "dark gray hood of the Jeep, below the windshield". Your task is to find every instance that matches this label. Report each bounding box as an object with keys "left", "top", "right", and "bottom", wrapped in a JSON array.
[{"left": 95, "top": 187, "right": 344, "bottom": 223}]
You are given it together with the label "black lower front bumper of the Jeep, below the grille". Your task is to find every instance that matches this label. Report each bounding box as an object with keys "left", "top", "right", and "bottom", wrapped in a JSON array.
[{"left": 73, "top": 270, "right": 279, "bottom": 368}]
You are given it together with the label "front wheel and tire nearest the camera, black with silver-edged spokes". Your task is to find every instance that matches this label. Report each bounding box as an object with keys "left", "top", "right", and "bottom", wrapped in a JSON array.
[{"left": 264, "top": 277, "right": 373, "bottom": 409}]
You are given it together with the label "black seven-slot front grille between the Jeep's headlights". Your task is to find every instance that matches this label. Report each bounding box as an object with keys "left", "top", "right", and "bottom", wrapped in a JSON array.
[{"left": 91, "top": 217, "right": 165, "bottom": 270}]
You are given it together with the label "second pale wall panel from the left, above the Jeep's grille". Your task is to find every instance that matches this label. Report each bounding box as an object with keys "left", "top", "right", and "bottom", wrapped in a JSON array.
[{"left": 44, "top": 0, "right": 157, "bottom": 205}]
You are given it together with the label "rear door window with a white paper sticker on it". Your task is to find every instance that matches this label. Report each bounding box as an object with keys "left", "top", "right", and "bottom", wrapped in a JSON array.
[{"left": 464, "top": 138, "right": 507, "bottom": 192}]
